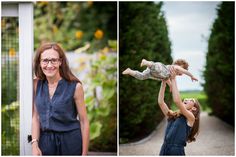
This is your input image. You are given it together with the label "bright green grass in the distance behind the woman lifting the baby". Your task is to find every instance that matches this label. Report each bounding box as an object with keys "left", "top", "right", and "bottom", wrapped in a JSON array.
[{"left": 171, "top": 91, "right": 212, "bottom": 113}]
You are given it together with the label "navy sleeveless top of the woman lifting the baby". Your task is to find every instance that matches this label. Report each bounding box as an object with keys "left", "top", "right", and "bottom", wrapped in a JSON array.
[{"left": 164, "top": 116, "right": 191, "bottom": 146}]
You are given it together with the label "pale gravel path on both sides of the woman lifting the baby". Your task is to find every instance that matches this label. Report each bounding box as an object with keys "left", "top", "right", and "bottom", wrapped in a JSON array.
[{"left": 119, "top": 112, "right": 235, "bottom": 155}]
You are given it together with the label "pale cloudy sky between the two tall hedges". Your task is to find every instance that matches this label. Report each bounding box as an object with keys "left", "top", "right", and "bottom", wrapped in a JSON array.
[{"left": 162, "top": 1, "right": 221, "bottom": 91}]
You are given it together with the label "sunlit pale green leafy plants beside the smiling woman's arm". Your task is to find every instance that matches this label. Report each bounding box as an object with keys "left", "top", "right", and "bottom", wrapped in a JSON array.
[{"left": 85, "top": 52, "right": 117, "bottom": 152}]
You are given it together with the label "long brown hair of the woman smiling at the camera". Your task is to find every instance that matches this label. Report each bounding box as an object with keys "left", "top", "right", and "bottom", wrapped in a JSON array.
[{"left": 34, "top": 43, "right": 81, "bottom": 83}]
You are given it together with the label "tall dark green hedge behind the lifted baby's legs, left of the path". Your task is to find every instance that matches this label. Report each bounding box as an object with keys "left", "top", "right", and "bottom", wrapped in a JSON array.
[{"left": 119, "top": 2, "right": 172, "bottom": 143}]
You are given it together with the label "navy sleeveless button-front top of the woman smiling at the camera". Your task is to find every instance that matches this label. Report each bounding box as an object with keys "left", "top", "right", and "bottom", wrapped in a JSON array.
[{"left": 35, "top": 78, "right": 80, "bottom": 132}]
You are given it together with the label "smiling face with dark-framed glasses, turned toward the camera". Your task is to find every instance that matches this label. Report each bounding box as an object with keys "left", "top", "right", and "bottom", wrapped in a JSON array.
[{"left": 40, "top": 49, "right": 61, "bottom": 77}]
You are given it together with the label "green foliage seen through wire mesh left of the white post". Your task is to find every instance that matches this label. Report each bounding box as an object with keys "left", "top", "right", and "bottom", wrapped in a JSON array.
[{"left": 1, "top": 17, "right": 20, "bottom": 155}]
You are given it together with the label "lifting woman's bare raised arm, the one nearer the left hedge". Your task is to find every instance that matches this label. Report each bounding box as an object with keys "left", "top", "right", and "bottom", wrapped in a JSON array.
[{"left": 158, "top": 81, "right": 169, "bottom": 117}]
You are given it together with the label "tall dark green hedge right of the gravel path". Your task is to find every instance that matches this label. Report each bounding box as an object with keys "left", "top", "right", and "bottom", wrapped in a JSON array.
[{"left": 204, "top": 2, "right": 235, "bottom": 125}]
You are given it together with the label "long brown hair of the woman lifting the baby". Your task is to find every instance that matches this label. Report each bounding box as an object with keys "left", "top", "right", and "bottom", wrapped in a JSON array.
[{"left": 167, "top": 99, "right": 201, "bottom": 142}]
